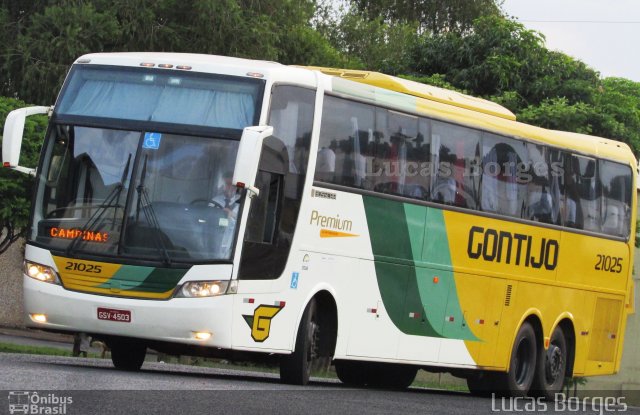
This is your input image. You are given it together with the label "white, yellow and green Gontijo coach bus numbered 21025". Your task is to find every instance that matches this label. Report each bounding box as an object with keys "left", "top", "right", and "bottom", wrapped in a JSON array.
[{"left": 3, "top": 53, "right": 636, "bottom": 399}]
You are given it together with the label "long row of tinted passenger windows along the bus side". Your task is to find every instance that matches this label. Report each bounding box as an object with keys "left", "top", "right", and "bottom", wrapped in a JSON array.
[{"left": 315, "top": 96, "right": 631, "bottom": 240}]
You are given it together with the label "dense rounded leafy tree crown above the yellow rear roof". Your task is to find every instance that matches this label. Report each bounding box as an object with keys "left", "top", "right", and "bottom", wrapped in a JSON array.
[{"left": 413, "top": 16, "right": 599, "bottom": 112}]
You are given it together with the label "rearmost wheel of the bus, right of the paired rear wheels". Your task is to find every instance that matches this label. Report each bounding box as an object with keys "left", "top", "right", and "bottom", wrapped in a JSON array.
[{"left": 532, "top": 327, "right": 568, "bottom": 401}]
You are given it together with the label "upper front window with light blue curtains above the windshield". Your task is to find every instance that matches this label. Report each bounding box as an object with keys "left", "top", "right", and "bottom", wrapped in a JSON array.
[{"left": 55, "top": 65, "right": 265, "bottom": 130}]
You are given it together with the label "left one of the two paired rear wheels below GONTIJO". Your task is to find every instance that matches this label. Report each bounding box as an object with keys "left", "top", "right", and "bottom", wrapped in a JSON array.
[{"left": 496, "top": 322, "right": 538, "bottom": 397}]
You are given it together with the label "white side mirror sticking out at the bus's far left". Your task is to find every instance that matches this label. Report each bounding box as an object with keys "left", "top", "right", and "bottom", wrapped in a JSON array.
[{"left": 2, "top": 107, "right": 51, "bottom": 176}]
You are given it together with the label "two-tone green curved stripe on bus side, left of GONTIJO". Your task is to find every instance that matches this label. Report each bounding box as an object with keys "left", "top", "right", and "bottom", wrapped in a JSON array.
[{"left": 363, "top": 196, "right": 477, "bottom": 340}]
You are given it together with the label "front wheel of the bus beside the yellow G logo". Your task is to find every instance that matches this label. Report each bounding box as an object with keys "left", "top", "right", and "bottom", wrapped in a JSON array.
[{"left": 280, "top": 299, "right": 321, "bottom": 385}]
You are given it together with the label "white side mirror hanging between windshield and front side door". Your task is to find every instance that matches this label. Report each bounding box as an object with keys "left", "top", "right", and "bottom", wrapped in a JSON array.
[{"left": 232, "top": 126, "right": 273, "bottom": 196}]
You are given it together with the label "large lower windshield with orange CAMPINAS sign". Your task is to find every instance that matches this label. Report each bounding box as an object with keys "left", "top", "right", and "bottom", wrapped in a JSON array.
[{"left": 31, "top": 125, "right": 241, "bottom": 263}]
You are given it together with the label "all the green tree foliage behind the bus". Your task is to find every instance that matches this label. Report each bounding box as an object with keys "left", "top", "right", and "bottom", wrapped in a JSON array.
[{"left": 0, "top": 0, "right": 640, "bottom": 252}]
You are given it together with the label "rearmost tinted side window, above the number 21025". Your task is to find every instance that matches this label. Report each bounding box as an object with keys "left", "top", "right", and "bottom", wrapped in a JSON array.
[{"left": 598, "top": 160, "right": 632, "bottom": 238}]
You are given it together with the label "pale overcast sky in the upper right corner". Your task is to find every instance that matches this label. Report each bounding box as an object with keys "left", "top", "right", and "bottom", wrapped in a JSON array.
[{"left": 502, "top": 0, "right": 640, "bottom": 82}]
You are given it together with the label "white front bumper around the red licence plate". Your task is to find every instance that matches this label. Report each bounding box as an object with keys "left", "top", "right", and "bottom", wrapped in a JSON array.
[{"left": 23, "top": 275, "right": 233, "bottom": 349}]
